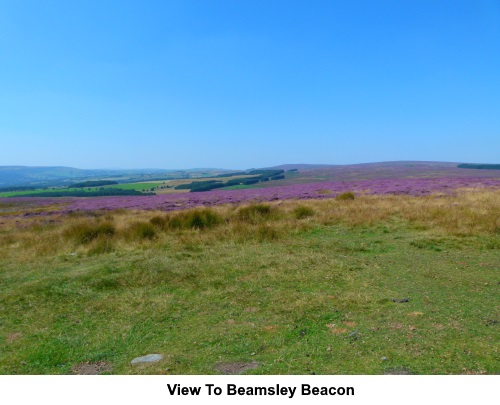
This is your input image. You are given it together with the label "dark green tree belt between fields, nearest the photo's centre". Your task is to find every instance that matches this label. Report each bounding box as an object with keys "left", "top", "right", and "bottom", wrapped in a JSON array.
[{"left": 175, "top": 170, "right": 285, "bottom": 192}]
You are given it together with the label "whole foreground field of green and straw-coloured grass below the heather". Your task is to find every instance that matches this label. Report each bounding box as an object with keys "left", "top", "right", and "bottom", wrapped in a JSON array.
[{"left": 0, "top": 190, "right": 500, "bottom": 374}]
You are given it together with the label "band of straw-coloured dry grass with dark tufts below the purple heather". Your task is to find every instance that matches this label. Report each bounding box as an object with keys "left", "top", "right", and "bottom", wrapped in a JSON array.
[{"left": 0, "top": 190, "right": 500, "bottom": 258}]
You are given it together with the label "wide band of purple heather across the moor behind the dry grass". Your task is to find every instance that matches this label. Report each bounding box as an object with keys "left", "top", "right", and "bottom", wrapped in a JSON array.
[{"left": 0, "top": 177, "right": 500, "bottom": 214}]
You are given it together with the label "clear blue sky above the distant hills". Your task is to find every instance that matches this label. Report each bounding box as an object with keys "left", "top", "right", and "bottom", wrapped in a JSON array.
[{"left": 0, "top": 0, "right": 500, "bottom": 169}]
